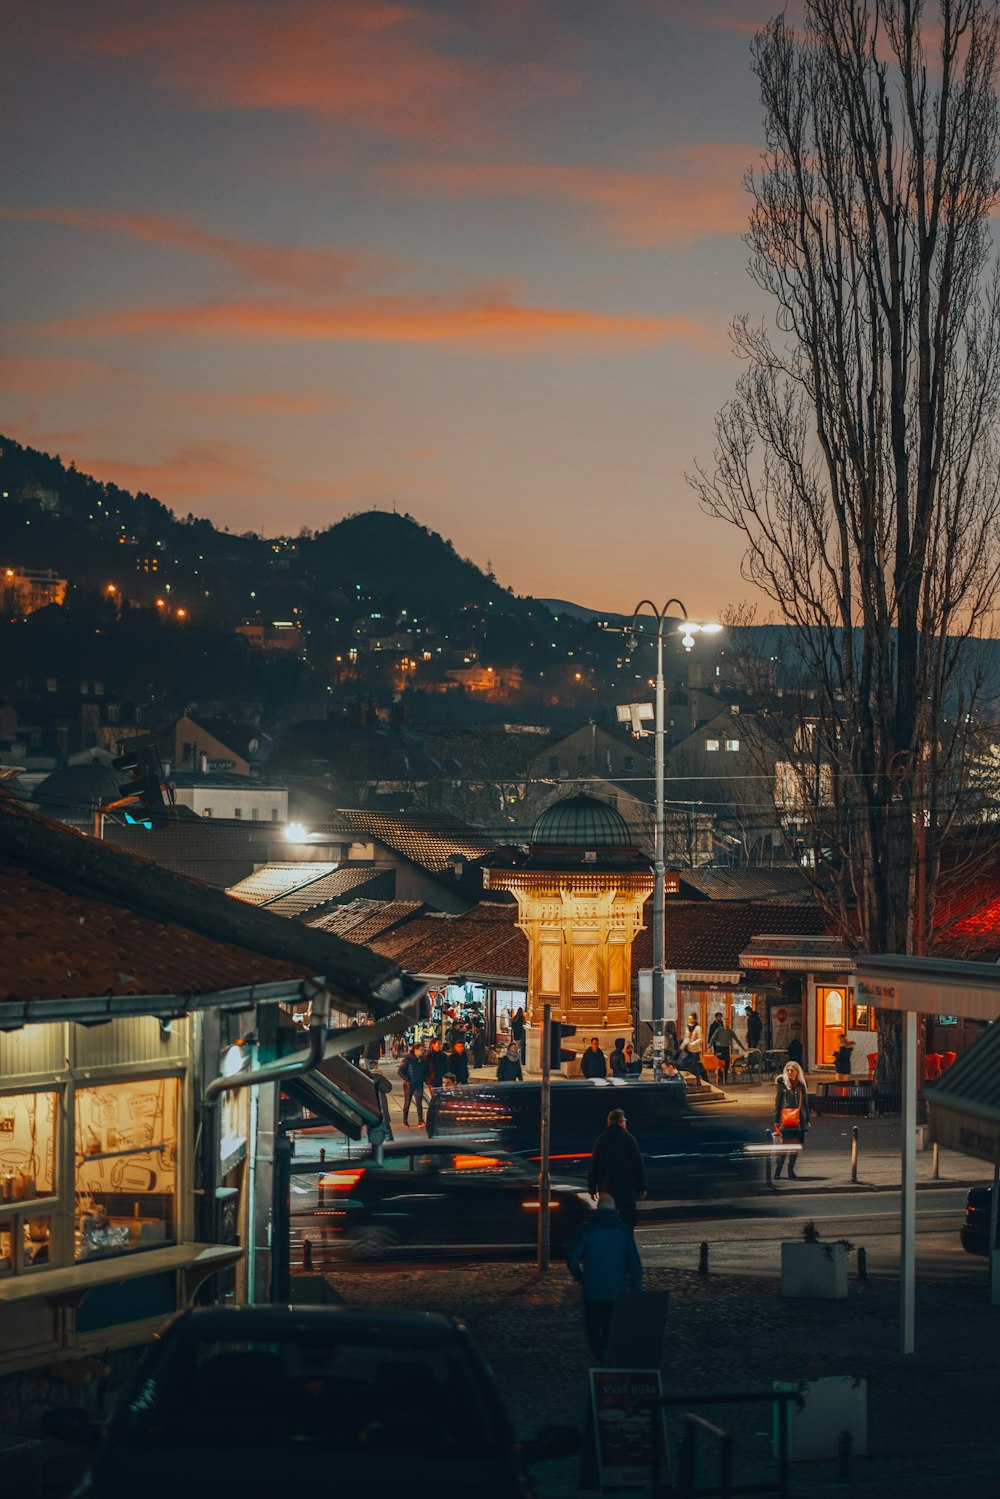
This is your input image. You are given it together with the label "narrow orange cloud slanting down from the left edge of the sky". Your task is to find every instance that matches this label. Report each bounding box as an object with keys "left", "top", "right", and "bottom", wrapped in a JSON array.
[{"left": 0, "top": 207, "right": 377, "bottom": 292}]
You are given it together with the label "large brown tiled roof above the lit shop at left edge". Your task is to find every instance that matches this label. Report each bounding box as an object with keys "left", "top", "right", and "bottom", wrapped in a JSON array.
[{"left": 0, "top": 797, "right": 410, "bottom": 1010}]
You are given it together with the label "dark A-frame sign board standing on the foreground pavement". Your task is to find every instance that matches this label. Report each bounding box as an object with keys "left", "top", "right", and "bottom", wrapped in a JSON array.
[{"left": 591, "top": 1369, "right": 667, "bottom": 1493}]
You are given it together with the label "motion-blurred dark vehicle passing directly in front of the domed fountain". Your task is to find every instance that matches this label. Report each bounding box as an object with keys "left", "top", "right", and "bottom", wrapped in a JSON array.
[{"left": 427, "top": 1078, "right": 763, "bottom": 1198}]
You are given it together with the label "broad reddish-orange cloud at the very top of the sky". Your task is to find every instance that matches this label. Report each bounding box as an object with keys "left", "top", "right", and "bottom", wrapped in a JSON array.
[{"left": 90, "top": 0, "right": 579, "bottom": 142}]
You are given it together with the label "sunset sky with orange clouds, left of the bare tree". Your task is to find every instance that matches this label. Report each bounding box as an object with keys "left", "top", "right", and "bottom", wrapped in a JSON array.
[{"left": 0, "top": 0, "right": 780, "bottom": 619}]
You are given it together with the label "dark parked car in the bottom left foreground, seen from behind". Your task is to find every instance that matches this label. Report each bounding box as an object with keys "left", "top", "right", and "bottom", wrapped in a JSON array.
[{"left": 45, "top": 1307, "right": 579, "bottom": 1499}]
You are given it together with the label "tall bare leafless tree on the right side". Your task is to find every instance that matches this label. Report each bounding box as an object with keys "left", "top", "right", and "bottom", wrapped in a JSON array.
[{"left": 691, "top": 0, "right": 1000, "bottom": 1087}]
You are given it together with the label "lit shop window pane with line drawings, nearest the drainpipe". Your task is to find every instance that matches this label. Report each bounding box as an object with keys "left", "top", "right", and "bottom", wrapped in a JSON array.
[{"left": 73, "top": 1078, "right": 180, "bottom": 1259}]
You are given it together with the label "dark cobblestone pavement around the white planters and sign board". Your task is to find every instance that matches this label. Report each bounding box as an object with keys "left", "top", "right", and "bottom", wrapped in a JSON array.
[{"left": 322, "top": 1264, "right": 1000, "bottom": 1499}]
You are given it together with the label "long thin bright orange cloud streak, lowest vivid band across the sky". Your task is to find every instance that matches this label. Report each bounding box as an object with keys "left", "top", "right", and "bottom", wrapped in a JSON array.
[{"left": 45, "top": 295, "right": 718, "bottom": 348}]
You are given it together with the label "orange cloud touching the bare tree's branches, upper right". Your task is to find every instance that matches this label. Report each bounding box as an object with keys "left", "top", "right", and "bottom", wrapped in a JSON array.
[{"left": 382, "top": 142, "right": 754, "bottom": 249}]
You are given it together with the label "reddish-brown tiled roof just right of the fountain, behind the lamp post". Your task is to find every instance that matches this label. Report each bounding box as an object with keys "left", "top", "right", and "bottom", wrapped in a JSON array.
[{"left": 633, "top": 901, "right": 826, "bottom": 973}]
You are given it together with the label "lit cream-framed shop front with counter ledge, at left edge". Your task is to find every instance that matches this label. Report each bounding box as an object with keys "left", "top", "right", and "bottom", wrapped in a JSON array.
[{"left": 0, "top": 1016, "right": 241, "bottom": 1370}]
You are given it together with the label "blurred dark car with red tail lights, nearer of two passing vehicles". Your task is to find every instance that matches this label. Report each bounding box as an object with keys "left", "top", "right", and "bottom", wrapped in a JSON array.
[{"left": 305, "top": 1144, "right": 594, "bottom": 1259}]
